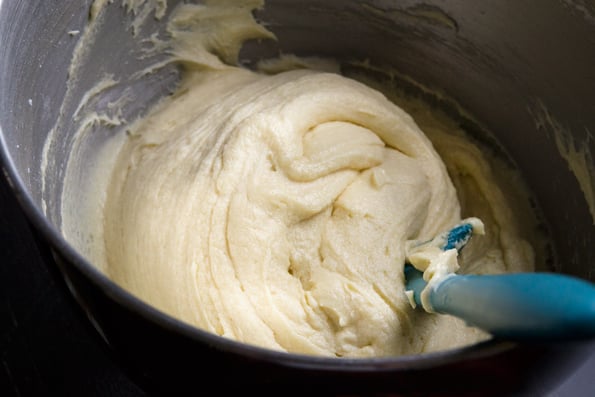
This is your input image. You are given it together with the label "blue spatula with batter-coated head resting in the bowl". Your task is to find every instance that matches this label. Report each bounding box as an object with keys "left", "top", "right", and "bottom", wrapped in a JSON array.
[{"left": 405, "top": 223, "right": 595, "bottom": 340}]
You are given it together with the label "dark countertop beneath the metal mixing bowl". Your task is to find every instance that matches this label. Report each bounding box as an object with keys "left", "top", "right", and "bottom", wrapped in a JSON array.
[{"left": 0, "top": 177, "right": 595, "bottom": 397}]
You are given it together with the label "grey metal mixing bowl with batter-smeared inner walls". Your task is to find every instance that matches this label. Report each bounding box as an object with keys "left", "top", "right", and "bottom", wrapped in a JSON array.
[{"left": 0, "top": 0, "right": 595, "bottom": 396}]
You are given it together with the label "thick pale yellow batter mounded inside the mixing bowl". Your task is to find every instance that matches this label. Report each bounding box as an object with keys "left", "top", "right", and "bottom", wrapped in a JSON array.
[{"left": 66, "top": 2, "right": 534, "bottom": 357}]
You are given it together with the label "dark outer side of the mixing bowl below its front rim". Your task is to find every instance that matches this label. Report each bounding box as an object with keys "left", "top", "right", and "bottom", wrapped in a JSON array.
[{"left": 39, "top": 244, "right": 589, "bottom": 396}]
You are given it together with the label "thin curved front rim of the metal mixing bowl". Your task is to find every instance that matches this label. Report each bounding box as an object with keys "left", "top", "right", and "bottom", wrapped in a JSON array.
[{"left": 0, "top": 132, "right": 518, "bottom": 372}]
